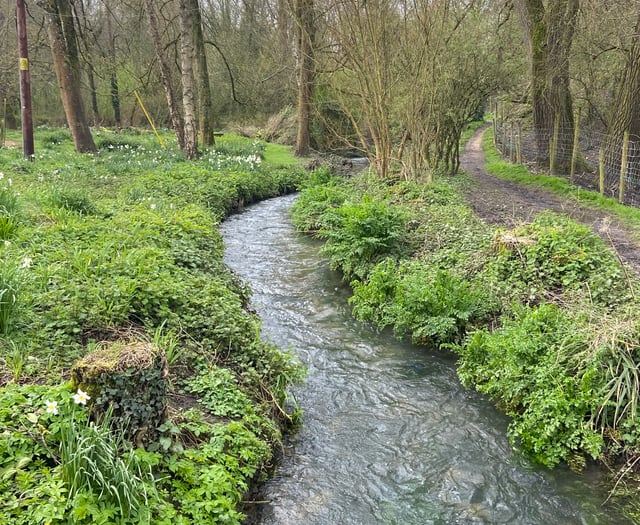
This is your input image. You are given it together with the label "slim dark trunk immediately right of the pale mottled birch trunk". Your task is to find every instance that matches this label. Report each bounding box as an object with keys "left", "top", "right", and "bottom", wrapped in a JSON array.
[{"left": 191, "top": 0, "right": 215, "bottom": 146}]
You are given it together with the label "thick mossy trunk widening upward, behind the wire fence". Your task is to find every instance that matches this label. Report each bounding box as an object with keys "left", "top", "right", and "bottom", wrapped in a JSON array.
[{"left": 517, "top": 0, "right": 579, "bottom": 169}]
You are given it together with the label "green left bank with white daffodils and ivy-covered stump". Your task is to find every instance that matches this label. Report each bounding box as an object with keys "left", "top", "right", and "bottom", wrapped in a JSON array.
[{"left": 0, "top": 129, "right": 307, "bottom": 525}]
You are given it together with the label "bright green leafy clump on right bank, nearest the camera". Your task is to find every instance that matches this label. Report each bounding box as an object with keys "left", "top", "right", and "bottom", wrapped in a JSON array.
[{"left": 457, "top": 304, "right": 604, "bottom": 466}]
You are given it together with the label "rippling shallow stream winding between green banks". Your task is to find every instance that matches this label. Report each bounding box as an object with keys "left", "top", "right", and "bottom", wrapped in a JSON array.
[{"left": 221, "top": 196, "right": 627, "bottom": 525}]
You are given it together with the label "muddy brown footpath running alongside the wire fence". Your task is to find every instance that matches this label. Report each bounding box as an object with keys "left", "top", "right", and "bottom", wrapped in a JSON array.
[{"left": 460, "top": 128, "right": 640, "bottom": 274}]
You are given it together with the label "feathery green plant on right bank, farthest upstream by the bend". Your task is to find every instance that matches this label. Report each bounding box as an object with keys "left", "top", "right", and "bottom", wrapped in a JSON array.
[{"left": 319, "top": 195, "right": 406, "bottom": 281}]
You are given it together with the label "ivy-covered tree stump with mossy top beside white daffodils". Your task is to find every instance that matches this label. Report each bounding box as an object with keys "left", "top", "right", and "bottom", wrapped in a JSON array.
[{"left": 71, "top": 342, "right": 167, "bottom": 446}]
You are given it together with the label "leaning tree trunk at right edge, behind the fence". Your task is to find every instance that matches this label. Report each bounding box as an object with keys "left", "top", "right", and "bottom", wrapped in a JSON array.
[{"left": 603, "top": 13, "right": 640, "bottom": 182}]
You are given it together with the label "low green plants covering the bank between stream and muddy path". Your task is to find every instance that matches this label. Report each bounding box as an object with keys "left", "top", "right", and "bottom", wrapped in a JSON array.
[{"left": 293, "top": 146, "right": 640, "bottom": 512}]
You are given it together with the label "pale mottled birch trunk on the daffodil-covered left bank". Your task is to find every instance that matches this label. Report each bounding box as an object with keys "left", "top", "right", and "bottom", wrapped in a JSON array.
[{"left": 180, "top": 0, "right": 199, "bottom": 160}]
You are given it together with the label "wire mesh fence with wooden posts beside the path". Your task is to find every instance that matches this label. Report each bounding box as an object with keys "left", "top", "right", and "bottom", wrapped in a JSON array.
[{"left": 494, "top": 118, "right": 640, "bottom": 207}]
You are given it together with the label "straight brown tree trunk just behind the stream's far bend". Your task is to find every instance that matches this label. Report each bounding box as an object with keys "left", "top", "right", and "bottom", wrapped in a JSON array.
[{"left": 294, "top": 0, "right": 315, "bottom": 156}]
